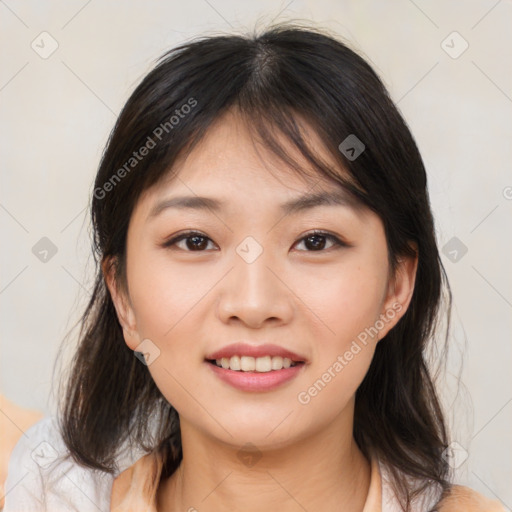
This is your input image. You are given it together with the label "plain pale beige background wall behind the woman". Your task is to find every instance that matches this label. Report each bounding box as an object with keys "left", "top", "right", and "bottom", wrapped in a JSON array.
[{"left": 0, "top": 0, "right": 512, "bottom": 509}]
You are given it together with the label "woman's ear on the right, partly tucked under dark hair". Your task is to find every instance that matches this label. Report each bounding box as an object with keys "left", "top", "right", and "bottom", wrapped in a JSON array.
[{"left": 378, "top": 251, "right": 418, "bottom": 340}]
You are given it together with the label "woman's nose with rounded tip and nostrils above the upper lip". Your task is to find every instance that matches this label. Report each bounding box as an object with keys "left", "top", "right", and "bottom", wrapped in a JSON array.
[{"left": 217, "top": 251, "right": 294, "bottom": 329}]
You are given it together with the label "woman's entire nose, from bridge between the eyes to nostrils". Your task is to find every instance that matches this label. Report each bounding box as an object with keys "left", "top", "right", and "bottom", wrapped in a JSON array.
[{"left": 219, "top": 237, "right": 292, "bottom": 327}]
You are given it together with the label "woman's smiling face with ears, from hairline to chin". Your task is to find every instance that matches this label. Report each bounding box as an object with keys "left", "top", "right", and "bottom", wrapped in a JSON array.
[{"left": 109, "top": 114, "right": 415, "bottom": 447}]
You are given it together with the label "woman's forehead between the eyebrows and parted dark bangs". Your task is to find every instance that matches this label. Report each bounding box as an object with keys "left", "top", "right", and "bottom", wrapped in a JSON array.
[{"left": 142, "top": 111, "right": 362, "bottom": 207}]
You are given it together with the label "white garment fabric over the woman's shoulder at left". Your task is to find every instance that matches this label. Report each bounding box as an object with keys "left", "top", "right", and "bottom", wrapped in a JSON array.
[{"left": 4, "top": 417, "right": 114, "bottom": 512}]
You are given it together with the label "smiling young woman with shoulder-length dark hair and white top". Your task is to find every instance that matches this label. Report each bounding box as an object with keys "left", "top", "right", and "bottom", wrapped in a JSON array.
[{"left": 6, "top": 26, "right": 502, "bottom": 512}]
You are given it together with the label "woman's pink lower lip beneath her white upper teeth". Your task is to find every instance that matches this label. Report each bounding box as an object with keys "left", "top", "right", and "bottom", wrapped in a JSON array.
[{"left": 205, "top": 361, "right": 305, "bottom": 391}]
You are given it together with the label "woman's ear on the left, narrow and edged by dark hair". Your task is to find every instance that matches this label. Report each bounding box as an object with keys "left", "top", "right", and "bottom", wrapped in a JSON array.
[{"left": 101, "top": 257, "right": 141, "bottom": 350}]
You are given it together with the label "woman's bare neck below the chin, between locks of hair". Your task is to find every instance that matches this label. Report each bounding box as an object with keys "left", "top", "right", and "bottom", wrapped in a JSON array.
[{"left": 157, "top": 408, "right": 370, "bottom": 512}]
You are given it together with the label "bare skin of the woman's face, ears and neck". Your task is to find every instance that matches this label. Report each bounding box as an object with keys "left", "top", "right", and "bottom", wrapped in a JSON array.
[{"left": 104, "top": 112, "right": 417, "bottom": 512}]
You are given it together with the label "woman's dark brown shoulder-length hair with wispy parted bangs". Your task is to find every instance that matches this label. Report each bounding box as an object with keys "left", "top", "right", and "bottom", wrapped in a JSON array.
[{"left": 59, "top": 25, "right": 451, "bottom": 510}]
